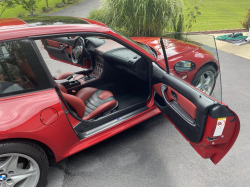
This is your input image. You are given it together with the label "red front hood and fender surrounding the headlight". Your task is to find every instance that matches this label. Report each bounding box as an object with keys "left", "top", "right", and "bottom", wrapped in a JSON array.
[{"left": 131, "top": 37, "right": 219, "bottom": 83}]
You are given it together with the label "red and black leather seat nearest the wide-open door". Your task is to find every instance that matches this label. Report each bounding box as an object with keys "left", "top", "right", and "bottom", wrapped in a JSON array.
[{"left": 57, "top": 83, "right": 118, "bottom": 120}]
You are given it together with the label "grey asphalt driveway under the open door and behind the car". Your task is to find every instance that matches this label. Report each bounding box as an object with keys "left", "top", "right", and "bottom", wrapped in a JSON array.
[{"left": 47, "top": 0, "right": 250, "bottom": 187}]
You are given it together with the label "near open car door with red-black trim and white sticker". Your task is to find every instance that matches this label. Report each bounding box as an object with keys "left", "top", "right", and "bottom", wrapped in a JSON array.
[{"left": 152, "top": 35, "right": 240, "bottom": 164}]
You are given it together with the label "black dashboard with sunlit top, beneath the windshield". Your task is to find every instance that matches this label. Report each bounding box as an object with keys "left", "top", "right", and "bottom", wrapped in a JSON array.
[{"left": 85, "top": 37, "right": 149, "bottom": 81}]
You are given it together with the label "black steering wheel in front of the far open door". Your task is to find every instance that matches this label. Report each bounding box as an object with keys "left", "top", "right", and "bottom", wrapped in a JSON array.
[{"left": 71, "top": 36, "right": 90, "bottom": 64}]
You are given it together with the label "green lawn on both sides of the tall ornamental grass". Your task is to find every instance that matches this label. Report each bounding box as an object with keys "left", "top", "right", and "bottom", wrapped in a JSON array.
[{"left": 1, "top": 0, "right": 250, "bottom": 31}]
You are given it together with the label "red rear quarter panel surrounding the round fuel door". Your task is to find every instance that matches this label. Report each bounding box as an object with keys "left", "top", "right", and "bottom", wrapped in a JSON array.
[{"left": 0, "top": 89, "right": 79, "bottom": 160}]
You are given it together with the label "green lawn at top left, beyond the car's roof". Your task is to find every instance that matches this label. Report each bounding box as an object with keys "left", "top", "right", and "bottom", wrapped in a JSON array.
[{"left": 1, "top": 0, "right": 84, "bottom": 18}]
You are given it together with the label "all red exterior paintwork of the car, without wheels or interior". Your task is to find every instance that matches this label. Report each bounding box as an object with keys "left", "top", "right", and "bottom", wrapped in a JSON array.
[{"left": 0, "top": 16, "right": 240, "bottom": 164}]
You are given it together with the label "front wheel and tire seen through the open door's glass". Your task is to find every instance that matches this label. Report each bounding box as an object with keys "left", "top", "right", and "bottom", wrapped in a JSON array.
[{"left": 191, "top": 64, "right": 217, "bottom": 95}]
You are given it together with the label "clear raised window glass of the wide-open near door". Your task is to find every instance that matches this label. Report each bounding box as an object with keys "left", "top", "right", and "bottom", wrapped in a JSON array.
[{"left": 162, "top": 33, "right": 222, "bottom": 102}]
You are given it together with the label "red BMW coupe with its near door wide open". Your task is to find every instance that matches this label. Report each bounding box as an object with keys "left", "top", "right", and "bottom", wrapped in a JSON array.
[{"left": 0, "top": 17, "right": 240, "bottom": 187}]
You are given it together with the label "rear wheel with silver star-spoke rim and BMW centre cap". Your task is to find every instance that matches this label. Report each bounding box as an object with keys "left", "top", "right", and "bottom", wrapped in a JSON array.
[{"left": 0, "top": 140, "right": 49, "bottom": 187}]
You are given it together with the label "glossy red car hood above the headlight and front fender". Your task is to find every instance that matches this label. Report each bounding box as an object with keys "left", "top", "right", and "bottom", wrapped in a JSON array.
[{"left": 131, "top": 37, "right": 199, "bottom": 58}]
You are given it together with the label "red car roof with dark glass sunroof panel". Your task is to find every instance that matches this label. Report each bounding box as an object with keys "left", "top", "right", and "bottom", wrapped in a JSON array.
[{"left": 0, "top": 16, "right": 111, "bottom": 40}]
